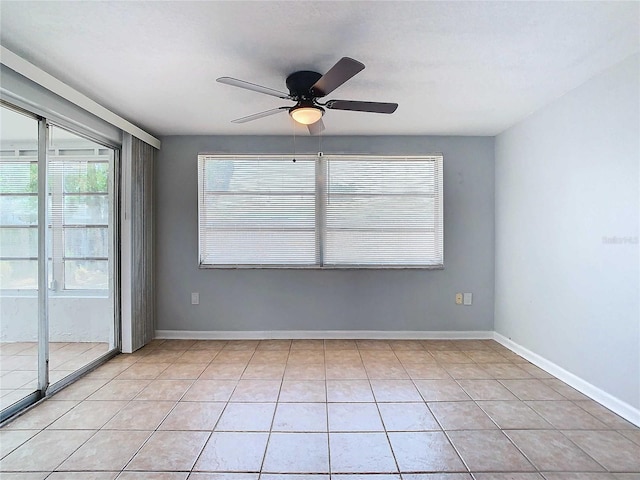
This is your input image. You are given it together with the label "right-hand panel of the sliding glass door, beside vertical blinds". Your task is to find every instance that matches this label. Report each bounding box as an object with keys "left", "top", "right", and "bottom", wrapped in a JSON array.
[{"left": 47, "top": 125, "right": 116, "bottom": 385}]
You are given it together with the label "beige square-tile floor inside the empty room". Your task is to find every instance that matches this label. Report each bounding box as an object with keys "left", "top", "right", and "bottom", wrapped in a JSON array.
[{"left": 0, "top": 340, "right": 640, "bottom": 480}]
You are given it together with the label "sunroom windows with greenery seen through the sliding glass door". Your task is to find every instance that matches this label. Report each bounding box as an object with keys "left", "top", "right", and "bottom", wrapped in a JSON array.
[{"left": 0, "top": 120, "right": 114, "bottom": 291}]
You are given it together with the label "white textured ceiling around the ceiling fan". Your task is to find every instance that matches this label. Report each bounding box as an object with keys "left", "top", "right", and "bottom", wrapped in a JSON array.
[{"left": 0, "top": 1, "right": 640, "bottom": 135}]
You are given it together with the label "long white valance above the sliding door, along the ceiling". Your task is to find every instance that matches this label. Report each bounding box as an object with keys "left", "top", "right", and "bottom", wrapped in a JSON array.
[{"left": 0, "top": 46, "right": 160, "bottom": 149}]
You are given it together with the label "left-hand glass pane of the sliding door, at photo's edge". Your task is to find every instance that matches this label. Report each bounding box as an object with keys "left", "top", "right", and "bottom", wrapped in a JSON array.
[{"left": 0, "top": 107, "right": 39, "bottom": 412}]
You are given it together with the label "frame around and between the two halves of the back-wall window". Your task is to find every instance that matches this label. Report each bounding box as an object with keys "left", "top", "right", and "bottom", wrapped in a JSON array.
[{"left": 197, "top": 152, "right": 444, "bottom": 270}]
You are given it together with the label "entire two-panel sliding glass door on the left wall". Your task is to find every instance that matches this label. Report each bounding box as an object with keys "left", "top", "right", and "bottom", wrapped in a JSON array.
[{"left": 0, "top": 102, "right": 119, "bottom": 418}]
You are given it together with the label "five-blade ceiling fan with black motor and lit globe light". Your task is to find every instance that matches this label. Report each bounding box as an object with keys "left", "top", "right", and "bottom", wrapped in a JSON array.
[{"left": 216, "top": 57, "right": 398, "bottom": 135}]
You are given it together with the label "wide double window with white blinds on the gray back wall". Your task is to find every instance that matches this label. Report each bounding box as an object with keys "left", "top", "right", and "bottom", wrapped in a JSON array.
[{"left": 198, "top": 155, "right": 443, "bottom": 268}]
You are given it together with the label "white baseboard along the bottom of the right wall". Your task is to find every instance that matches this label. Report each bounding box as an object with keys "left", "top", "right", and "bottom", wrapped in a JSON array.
[{"left": 493, "top": 332, "right": 640, "bottom": 426}]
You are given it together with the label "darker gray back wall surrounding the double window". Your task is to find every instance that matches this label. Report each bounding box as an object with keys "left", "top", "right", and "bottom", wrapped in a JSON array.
[{"left": 155, "top": 136, "right": 494, "bottom": 331}]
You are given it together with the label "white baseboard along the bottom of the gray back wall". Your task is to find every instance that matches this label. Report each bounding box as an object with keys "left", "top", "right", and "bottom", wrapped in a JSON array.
[{"left": 155, "top": 330, "right": 493, "bottom": 340}]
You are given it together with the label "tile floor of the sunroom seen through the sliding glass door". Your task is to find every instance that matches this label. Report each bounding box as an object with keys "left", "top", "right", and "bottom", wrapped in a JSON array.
[{"left": 0, "top": 342, "right": 109, "bottom": 410}]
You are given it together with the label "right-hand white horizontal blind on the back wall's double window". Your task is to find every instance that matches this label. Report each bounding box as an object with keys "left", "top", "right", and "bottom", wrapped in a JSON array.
[{"left": 323, "top": 157, "right": 443, "bottom": 266}]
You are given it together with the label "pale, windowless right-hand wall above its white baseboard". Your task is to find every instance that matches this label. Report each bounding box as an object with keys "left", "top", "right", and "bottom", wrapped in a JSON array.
[{"left": 495, "top": 55, "right": 640, "bottom": 408}]
